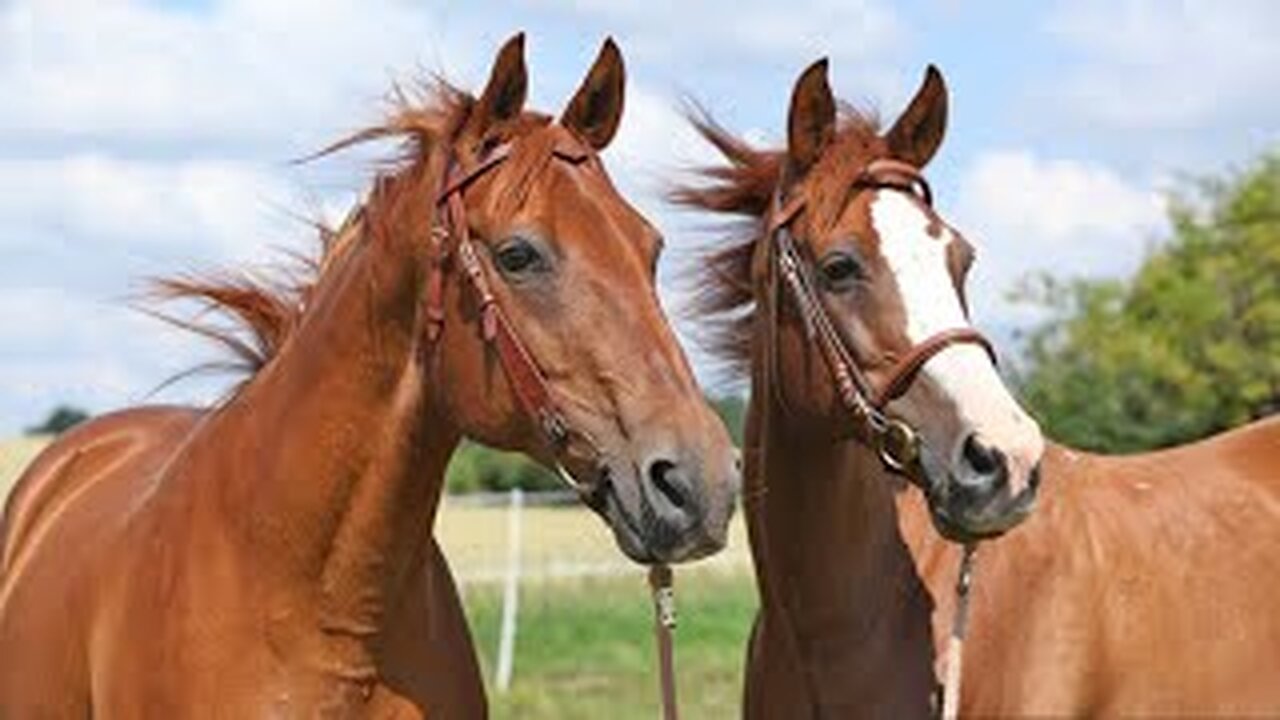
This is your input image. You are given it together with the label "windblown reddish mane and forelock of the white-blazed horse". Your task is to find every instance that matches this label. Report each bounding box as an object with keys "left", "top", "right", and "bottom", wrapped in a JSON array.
[{"left": 668, "top": 104, "right": 879, "bottom": 375}]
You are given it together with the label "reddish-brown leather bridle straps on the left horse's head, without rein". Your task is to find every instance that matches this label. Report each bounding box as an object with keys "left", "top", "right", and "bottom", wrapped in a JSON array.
[{"left": 424, "top": 132, "right": 602, "bottom": 505}]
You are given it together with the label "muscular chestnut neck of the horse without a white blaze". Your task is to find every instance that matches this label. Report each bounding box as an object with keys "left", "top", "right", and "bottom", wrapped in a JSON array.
[{"left": 192, "top": 180, "right": 458, "bottom": 639}]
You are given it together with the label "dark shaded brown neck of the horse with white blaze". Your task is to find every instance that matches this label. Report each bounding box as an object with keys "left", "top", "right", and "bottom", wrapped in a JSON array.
[{"left": 746, "top": 383, "right": 934, "bottom": 715}]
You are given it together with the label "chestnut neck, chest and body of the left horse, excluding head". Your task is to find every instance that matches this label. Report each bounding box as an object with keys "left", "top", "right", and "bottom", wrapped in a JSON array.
[{"left": 0, "top": 196, "right": 485, "bottom": 717}]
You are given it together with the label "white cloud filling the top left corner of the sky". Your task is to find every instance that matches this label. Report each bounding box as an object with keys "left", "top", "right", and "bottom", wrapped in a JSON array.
[{"left": 0, "top": 0, "right": 471, "bottom": 147}]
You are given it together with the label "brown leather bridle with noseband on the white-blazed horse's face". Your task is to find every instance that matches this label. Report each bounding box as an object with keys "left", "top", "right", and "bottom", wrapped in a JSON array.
[{"left": 765, "top": 159, "right": 996, "bottom": 481}]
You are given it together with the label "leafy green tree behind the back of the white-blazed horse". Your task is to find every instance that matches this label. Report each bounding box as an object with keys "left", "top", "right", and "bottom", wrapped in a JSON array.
[{"left": 1015, "top": 154, "right": 1280, "bottom": 452}]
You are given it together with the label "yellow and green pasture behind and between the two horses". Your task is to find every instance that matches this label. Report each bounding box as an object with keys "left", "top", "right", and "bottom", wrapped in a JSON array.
[{"left": 0, "top": 438, "right": 756, "bottom": 720}]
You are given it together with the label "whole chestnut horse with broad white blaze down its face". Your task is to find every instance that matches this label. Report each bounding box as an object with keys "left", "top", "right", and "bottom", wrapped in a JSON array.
[{"left": 673, "top": 61, "right": 1280, "bottom": 719}]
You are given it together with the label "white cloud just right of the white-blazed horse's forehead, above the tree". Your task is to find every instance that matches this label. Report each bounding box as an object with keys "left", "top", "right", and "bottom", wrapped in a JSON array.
[{"left": 952, "top": 150, "right": 1167, "bottom": 325}]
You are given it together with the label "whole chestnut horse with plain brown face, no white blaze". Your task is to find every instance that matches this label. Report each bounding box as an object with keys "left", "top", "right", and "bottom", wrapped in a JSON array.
[{"left": 0, "top": 36, "right": 739, "bottom": 717}]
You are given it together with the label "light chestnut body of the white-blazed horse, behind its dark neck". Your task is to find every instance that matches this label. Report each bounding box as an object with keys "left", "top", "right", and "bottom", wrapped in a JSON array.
[{"left": 957, "top": 419, "right": 1280, "bottom": 716}]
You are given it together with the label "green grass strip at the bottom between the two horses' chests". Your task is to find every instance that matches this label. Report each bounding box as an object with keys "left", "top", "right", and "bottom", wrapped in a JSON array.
[{"left": 466, "top": 573, "right": 756, "bottom": 720}]
